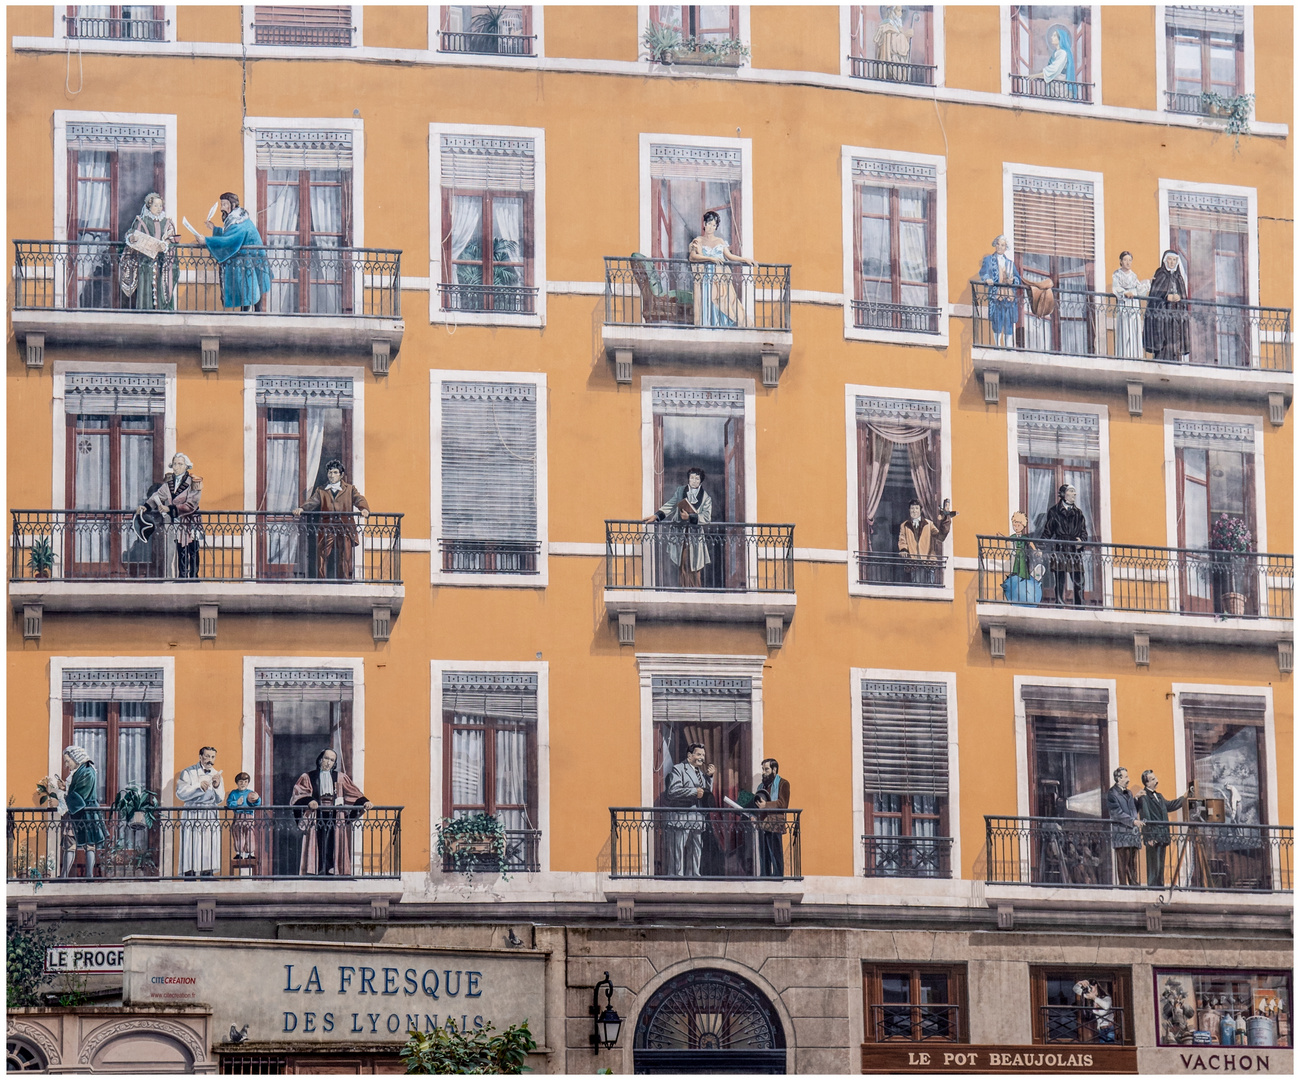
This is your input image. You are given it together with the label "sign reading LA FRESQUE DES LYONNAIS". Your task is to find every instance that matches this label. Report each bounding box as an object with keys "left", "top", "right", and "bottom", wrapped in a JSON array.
[{"left": 122, "top": 937, "right": 546, "bottom": 1045}]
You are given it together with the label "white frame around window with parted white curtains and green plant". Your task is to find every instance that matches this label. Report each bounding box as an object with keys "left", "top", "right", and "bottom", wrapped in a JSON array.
[{"left": 429, "top": 121, "right": 546, "bottom": 329}]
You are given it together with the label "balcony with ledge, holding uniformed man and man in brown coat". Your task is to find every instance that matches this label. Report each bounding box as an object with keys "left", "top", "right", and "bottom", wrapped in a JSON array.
[{"left": 9, "top": 509, "right": 406, "bottom": 639}]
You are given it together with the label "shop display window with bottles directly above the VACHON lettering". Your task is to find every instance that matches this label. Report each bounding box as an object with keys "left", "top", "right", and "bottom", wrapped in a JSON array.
[{"left": 1152, "top": 968, "right": 1294, "bottom": 1048}]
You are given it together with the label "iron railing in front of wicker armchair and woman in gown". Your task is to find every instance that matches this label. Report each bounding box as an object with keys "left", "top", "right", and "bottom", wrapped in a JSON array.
[{"left": 605, "top": 255, "right": 790, "bottom": 330}]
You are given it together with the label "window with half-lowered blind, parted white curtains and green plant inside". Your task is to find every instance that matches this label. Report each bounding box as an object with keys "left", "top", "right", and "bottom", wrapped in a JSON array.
[{"left": 438, "top": 134, "right": 537, "bottom": 315}]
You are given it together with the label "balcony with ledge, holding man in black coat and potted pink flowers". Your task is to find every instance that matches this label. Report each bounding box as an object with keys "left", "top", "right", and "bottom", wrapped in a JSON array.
[{"left": 976, "top": 535, "right": 1295, "bottom": 646}]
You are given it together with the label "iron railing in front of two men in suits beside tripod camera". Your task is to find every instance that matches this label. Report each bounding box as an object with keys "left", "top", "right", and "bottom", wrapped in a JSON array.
[{"left": 984, "top": 815, "right": 1295, "bottom": 893}]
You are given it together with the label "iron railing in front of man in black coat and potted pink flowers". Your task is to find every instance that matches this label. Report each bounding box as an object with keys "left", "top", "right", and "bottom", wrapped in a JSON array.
[{"left": 976, "top": 535, "right": 1295, "bottom": 619}]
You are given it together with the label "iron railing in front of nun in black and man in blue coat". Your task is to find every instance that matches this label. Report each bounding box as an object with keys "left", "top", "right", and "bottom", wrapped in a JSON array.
[{"left": 971, "top": 281, "right": 1291, "bottom": 372}]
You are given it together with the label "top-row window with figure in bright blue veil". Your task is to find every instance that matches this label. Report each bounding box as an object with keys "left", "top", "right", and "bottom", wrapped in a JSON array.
[{"left": 1010, "top": 4, "right": 1092, "bottom": 103}]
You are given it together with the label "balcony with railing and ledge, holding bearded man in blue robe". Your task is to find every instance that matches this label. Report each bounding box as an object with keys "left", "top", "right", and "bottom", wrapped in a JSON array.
[{"left": 13, "top": 240, "right": 404, "bottom": 372}]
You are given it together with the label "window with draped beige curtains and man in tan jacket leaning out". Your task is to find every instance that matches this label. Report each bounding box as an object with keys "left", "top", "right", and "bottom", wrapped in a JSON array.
[{"left": 854, "top": 395, "right": 948, "bottom": 586}]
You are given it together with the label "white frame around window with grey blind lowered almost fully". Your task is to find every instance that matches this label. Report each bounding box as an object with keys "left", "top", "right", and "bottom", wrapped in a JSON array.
[{"left": 429, "top": 369, "right": 550, "bottom": 589}]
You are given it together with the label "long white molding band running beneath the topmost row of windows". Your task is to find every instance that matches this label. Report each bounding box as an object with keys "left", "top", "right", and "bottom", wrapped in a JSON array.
[{"left": 13, "top": 38, "right": 1288, "bottom": 138}]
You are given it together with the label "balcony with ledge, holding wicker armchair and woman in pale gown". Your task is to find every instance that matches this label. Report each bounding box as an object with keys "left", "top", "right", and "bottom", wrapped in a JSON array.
[{"left": 601, "top": 255, "right": 793, "bottom": 386}]
